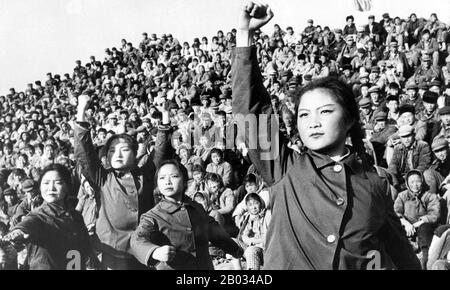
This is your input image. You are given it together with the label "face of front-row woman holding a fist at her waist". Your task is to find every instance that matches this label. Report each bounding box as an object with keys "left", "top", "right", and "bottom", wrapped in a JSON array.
[{"left": 158, "top": 164, "right": 184, "bottom": 200}]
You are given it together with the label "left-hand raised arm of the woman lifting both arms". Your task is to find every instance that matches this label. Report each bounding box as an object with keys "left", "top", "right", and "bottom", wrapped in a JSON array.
[{"left": 73, "top": 95, "right": 106, "bottom": 187}]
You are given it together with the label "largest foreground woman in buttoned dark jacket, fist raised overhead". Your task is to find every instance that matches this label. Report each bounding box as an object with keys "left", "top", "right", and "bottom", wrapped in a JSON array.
[{"left": 233, "top": 2, "right": 420, "bottom": 269}]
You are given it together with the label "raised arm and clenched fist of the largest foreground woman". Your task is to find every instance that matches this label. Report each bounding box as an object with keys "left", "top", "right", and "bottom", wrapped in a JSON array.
[{"left": 232, "top": 2, "right": 292, "bottom": 185}]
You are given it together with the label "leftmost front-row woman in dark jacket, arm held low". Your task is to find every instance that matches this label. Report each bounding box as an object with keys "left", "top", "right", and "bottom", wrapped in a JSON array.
[{"left": 3, "top": 164, "right": 91, "bottom": 270}]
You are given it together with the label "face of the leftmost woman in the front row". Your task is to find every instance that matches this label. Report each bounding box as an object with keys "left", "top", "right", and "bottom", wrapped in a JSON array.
[{"left": 40, "top": 170, "right": 68, "bottom": 203}]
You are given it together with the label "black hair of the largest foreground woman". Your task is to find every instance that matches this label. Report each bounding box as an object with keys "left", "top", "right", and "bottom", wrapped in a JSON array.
[{"left": 295, "top": 76, "right": 371, "bottom": 170}]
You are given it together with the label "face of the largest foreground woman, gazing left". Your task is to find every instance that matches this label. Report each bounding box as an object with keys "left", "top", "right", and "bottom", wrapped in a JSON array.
[{"left": 297, "top": 89, "right": 352, "bottom": 154}]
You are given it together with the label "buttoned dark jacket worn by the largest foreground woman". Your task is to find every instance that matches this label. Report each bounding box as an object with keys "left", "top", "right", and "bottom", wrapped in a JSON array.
[{"left": 233, "top": 47, "right": 420, "bottom": 269}]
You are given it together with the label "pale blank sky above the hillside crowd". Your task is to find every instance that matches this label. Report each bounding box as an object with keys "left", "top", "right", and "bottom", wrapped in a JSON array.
[{"left": 0, "top": 0, "right": 450, "bottom": 94}]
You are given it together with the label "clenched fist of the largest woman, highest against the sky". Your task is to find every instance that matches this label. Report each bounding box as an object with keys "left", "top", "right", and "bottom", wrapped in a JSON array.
[{"left": 239, "top": 1, "right": 274, "bottom": 31}]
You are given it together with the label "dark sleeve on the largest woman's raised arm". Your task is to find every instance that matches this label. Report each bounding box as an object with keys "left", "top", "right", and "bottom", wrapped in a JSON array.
[{"left": 232, "top": 47, "right": 293, "bottom": 185}]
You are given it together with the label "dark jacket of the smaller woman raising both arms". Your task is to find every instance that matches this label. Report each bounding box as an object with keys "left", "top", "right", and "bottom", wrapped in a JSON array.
[{"left": 74, "top": 124, "right": 171, "bottom": 258}]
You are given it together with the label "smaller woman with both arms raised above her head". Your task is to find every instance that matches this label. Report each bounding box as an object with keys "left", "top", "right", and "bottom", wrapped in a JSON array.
[{"left": 73, "top": 95, "right": 173, "bottom": 269}]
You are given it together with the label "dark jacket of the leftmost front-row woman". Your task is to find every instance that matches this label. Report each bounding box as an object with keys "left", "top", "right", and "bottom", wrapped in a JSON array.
[{"left": 14, "top": 202, "right": 91, "bottom": 270}]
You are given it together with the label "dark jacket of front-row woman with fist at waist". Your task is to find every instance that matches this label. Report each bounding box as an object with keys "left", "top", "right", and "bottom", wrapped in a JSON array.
[{"left": 131, "top": 196, "right": 243, "bottom": 270}]
